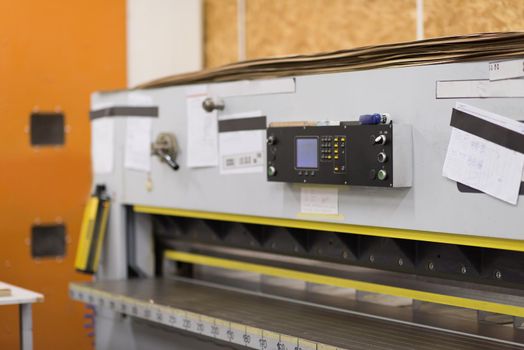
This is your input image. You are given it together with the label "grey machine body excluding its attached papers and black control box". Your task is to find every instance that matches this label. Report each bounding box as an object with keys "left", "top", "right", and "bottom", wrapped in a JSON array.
[{"left": 71, "top": 56, "right": 524, "bottom": 350}]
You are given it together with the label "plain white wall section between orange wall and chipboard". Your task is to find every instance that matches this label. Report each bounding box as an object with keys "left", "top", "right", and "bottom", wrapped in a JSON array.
[{"left": 127, "top": 0, "right": 203, "bottom": 87}]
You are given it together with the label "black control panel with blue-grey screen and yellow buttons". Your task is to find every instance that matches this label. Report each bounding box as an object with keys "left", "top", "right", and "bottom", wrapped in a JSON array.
[{"left": 267, "top": 124, "right": 394, "bottom": 187}]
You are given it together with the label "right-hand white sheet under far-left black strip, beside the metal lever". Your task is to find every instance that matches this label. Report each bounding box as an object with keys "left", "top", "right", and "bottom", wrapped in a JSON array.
[{"left": 124, "top": 117, "right": 152, "bottom": 172}]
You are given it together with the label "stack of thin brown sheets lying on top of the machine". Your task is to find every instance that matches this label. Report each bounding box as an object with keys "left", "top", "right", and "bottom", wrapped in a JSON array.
[{"left": 138, "top": 32, "right": 524, "bottom": 88}]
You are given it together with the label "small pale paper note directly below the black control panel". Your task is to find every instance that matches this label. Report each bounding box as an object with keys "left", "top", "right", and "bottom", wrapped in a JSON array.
[{"left": 300, "top": 186, "right": 338, "bottom": 215}]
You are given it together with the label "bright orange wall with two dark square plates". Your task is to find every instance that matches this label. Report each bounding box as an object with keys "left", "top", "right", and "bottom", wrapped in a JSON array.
[{"left": 0, "top": 0, "right": 126, "bottom": 350}]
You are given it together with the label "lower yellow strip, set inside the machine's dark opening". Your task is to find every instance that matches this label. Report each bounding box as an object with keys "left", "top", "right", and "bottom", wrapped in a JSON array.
[{"left": 164, "top": 250, "right": 524, "bottom": 317}]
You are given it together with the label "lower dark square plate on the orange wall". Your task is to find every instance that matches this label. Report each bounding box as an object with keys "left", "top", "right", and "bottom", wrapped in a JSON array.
[{"left": 31, "top": 224, "right": 66, "bottom": 258}]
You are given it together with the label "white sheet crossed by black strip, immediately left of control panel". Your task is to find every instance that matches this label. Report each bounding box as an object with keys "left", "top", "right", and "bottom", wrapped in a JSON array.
[{"left": 218, "top": 111, "right": 265, "bottom": 175}]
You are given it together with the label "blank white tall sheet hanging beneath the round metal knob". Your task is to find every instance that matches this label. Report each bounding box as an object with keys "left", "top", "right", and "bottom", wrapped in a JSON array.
[{"left": 186, "top": 95, "right": 218, "bottom": 168}]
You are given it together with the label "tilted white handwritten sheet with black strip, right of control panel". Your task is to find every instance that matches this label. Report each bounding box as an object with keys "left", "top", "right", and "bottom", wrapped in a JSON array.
[{"left": 443, "top": 103, "right": 524, "bottom": 205}]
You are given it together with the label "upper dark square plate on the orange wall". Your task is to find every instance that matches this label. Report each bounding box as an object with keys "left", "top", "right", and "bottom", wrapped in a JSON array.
[{"left": 30, "top": 112, "right": 65, "bottom": 146}]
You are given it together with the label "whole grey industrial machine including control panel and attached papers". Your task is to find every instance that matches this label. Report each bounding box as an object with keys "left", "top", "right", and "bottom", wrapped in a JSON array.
[{"left": 70, "top": 33, "right": 524, "bottom": 350}]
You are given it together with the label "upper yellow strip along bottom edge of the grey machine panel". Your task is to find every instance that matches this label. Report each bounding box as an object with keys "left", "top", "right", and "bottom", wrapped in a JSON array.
[{"left": 133, "top": 205, "right": 524, "bottom": 252}]
